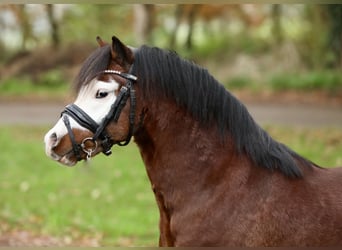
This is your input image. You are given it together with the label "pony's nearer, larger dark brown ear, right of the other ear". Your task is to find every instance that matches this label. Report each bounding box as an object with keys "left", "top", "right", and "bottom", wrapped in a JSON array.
[{"left": 111, "top": 36, "right": 134, "bottom": 66}]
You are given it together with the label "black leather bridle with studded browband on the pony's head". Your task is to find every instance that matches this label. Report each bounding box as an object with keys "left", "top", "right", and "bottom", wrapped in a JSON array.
[{"left": 61, "top": 67, "right": 138, "bottom": 160}]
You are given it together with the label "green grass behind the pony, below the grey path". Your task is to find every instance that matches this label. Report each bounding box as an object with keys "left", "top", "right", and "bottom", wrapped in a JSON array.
[{"left": 0, "top": 126, "right": 342, "bottom": 246}]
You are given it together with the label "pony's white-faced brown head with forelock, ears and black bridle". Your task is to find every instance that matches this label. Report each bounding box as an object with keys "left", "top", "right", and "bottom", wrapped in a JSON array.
[{"left": 44, "top": 37, "right": 137, "bottom": 166}]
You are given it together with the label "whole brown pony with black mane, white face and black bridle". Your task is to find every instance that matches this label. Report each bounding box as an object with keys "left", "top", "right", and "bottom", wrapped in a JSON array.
[{"left": 45, "top": 37, "right": 342, "bottom": 246}]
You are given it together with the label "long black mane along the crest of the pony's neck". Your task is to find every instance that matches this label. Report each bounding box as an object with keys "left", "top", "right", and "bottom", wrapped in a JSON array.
[{"left": 133, "top": 46, "right": 312, "bottom": 177}]
